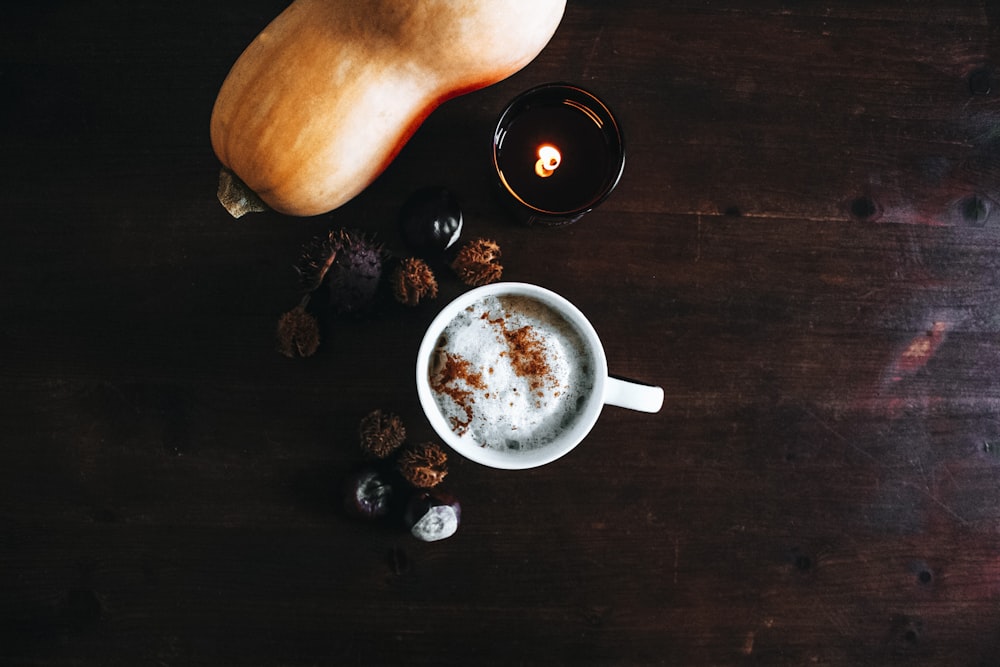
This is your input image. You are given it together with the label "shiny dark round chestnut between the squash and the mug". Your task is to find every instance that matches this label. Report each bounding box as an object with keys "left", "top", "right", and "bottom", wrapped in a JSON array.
[{"left": 399, "top": 187, "right": 462, "bottom": 254}]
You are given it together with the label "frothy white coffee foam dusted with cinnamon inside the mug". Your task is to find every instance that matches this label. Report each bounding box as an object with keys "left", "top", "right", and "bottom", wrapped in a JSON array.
[{"left": 429, "top": 296, "right": 594, "bottom": 450}]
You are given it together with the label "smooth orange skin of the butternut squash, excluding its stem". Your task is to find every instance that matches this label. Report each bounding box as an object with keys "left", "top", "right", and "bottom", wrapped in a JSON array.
[{"left": 210, "top": 0, "right": 565, "bottom": 216}]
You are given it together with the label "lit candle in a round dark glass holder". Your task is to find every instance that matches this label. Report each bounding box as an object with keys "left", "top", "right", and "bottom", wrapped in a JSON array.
[{"left": 493, "top": 84, "right": 625, "bottom": 225}]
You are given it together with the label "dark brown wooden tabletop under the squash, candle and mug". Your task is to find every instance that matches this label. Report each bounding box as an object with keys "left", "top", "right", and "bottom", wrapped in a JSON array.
[{"left": 0, "top": 0, "right": 1000, "bottom": 666}]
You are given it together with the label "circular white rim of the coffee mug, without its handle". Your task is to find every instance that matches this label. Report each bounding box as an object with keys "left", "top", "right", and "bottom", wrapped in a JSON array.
[{"left": 416, "top": 282, "right": 608, "bottom": 470}]
